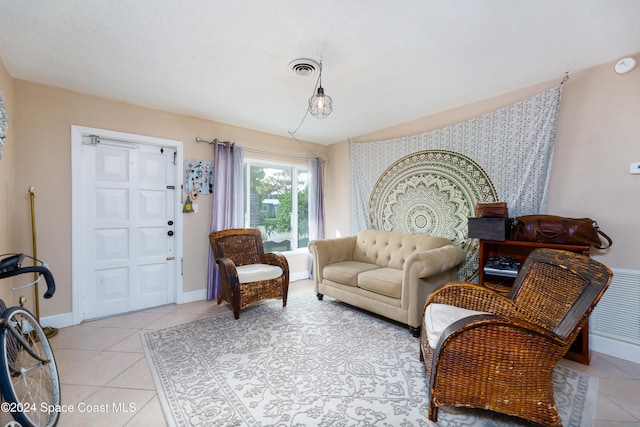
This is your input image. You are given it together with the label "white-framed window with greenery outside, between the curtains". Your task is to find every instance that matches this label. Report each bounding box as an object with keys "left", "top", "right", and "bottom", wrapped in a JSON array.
[{"left": 244, "top": 159, "right": 309, "bottom": 252}]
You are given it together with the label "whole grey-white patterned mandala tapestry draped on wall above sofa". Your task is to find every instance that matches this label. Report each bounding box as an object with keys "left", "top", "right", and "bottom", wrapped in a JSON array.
[{"left": 349, "top": 84, "right": 562, "bottom": 281}]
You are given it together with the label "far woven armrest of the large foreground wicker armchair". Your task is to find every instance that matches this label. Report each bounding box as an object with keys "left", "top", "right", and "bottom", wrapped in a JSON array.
[{"left": 425, "top": 282, "right": 522, "bottom": 318}]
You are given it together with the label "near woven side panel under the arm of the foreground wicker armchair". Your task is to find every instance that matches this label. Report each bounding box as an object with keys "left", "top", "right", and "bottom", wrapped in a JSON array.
[{"left": 430, "top": 314, "right": 569, "bottom": 418}]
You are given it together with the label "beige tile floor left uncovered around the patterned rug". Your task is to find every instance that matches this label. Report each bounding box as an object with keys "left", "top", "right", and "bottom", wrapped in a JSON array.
[{"left": 37, "top": 280, "right": 640, "bottom": 427}]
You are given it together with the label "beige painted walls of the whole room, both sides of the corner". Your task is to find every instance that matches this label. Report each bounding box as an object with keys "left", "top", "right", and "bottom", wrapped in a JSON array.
[{"left": 6, "top": 55, "right": 640, "bottom": 316}]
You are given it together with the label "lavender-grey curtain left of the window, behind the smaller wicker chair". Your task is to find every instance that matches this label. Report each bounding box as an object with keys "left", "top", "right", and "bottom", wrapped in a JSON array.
[{"left": 207, "top": 139, "right": 244, "bottom": 300}]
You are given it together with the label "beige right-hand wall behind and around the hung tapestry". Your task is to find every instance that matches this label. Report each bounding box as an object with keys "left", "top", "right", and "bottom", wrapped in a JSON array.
[{"left": 325, "top": 55, "right": 640, "bottom": 270}]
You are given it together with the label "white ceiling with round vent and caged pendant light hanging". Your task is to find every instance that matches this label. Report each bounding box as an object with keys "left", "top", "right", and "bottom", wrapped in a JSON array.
[{"left": 0, "top": 0, "right": 640, "bottom": 144}]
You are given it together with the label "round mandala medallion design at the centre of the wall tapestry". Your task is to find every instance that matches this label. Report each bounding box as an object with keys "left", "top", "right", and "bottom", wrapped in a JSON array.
[{"left": 369, "top": 150, "right": 498, "bottom": 280}]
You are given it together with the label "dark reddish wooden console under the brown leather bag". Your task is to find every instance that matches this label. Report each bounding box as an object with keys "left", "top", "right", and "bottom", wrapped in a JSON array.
[{"left": 478, "top": 240, "right": 591, "bottom": 365}]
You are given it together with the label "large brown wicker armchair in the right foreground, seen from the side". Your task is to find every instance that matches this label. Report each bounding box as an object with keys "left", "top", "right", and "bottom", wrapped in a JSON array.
[{"left": 420, "top": 249, "right": 613, "bottom": 426}]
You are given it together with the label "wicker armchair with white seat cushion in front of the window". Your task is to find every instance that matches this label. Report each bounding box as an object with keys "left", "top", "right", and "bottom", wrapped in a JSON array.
[{"left": 209, "top": 228, "right": 289, "bottom": 319}]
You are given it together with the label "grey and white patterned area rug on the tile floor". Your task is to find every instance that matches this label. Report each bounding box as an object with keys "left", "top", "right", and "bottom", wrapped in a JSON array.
[{"left": 142, "top": 292, "right": 598, "bottom": 427}]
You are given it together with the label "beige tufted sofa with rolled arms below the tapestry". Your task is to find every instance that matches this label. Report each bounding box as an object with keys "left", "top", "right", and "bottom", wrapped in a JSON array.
[{"left": 309, "top": 230, "right": 465, "bottom": 337}]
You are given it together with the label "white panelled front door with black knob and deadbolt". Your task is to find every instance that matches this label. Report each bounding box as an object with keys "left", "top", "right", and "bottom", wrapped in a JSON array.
[{"left": 75, "top": 128, "right": 180, "bottom": 320}]
